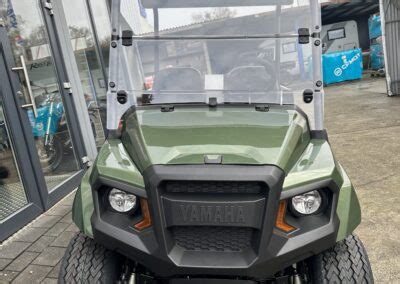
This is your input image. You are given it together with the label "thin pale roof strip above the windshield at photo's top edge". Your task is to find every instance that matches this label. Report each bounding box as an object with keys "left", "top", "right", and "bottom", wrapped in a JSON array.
[{"left": 141, "top": 0, "right": 293, "bottom": 9}]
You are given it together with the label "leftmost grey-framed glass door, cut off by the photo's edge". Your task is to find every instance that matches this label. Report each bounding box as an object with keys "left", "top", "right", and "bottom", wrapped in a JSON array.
[{"left": 0, "top": 25, "right": 43, "bottom": 241}]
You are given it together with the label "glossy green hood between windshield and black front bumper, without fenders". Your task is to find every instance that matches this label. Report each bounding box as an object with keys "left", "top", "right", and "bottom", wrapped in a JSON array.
[{"left": 122, "top": 106, "right": 310, "bottom": 172}]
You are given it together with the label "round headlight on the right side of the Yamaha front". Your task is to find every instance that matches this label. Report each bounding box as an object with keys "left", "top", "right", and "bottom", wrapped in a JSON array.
[{"left": 292, "top": 190, "right": 322, "bottom": 215}]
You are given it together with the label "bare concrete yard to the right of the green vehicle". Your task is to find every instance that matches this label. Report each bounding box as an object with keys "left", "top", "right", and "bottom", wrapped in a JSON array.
[{"left": 325, "top": 79, "right": 400, "bottom": 283}]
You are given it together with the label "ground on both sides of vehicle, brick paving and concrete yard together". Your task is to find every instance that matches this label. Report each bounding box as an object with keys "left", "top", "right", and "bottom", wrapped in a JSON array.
[{"left": 0, "top": 76, "right": 400, "bottom": 283}]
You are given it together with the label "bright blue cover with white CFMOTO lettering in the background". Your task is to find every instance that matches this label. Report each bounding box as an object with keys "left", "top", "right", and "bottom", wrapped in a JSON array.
[{"left": 322, "top": 48, "right": 363, "bottom": 85}]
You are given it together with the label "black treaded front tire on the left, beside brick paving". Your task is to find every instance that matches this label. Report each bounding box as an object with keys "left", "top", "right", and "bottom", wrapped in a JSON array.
[{"left": 58, "top": 233, "right": 123, "bottom": 283}]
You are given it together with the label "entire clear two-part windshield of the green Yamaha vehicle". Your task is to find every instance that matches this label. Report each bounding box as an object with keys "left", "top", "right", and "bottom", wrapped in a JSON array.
[{"left": 110, "top": 0, "right": 324, "bottom": 130}]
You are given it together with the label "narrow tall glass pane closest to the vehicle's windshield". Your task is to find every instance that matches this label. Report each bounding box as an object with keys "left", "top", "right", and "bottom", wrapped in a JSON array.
[{"left": 62, "top": 0, "right": 107, "bottom": 146}]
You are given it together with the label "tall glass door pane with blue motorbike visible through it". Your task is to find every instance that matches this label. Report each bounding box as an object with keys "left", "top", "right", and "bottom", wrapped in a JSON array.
[{"left": 0, "top": 0, "right": 78, "bottom": 190}]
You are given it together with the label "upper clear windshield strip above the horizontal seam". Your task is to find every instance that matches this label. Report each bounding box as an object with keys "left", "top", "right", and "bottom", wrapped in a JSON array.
[{"left": 120, "top": 0, "right": 311, "bottom": 36}]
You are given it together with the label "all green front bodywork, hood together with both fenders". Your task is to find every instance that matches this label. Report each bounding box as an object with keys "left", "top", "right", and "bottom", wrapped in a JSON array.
[{"left": 73, "top": 107, "right": 361, "bottom": 241}]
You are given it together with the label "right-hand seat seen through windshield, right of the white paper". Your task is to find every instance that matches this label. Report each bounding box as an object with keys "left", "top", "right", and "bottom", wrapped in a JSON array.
[{"left": 227, "top": 52, "right": 276, "bottom": 92}]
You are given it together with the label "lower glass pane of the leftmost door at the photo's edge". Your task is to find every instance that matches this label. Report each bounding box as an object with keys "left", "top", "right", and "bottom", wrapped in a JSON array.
[{"left": 0, "top": 100, "right": 28, "bottom": 222}]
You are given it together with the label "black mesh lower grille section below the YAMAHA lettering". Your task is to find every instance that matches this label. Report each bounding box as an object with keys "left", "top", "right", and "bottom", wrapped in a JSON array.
[{"left": 171, "top": 226, "right": 255, "bottom": 252}]
